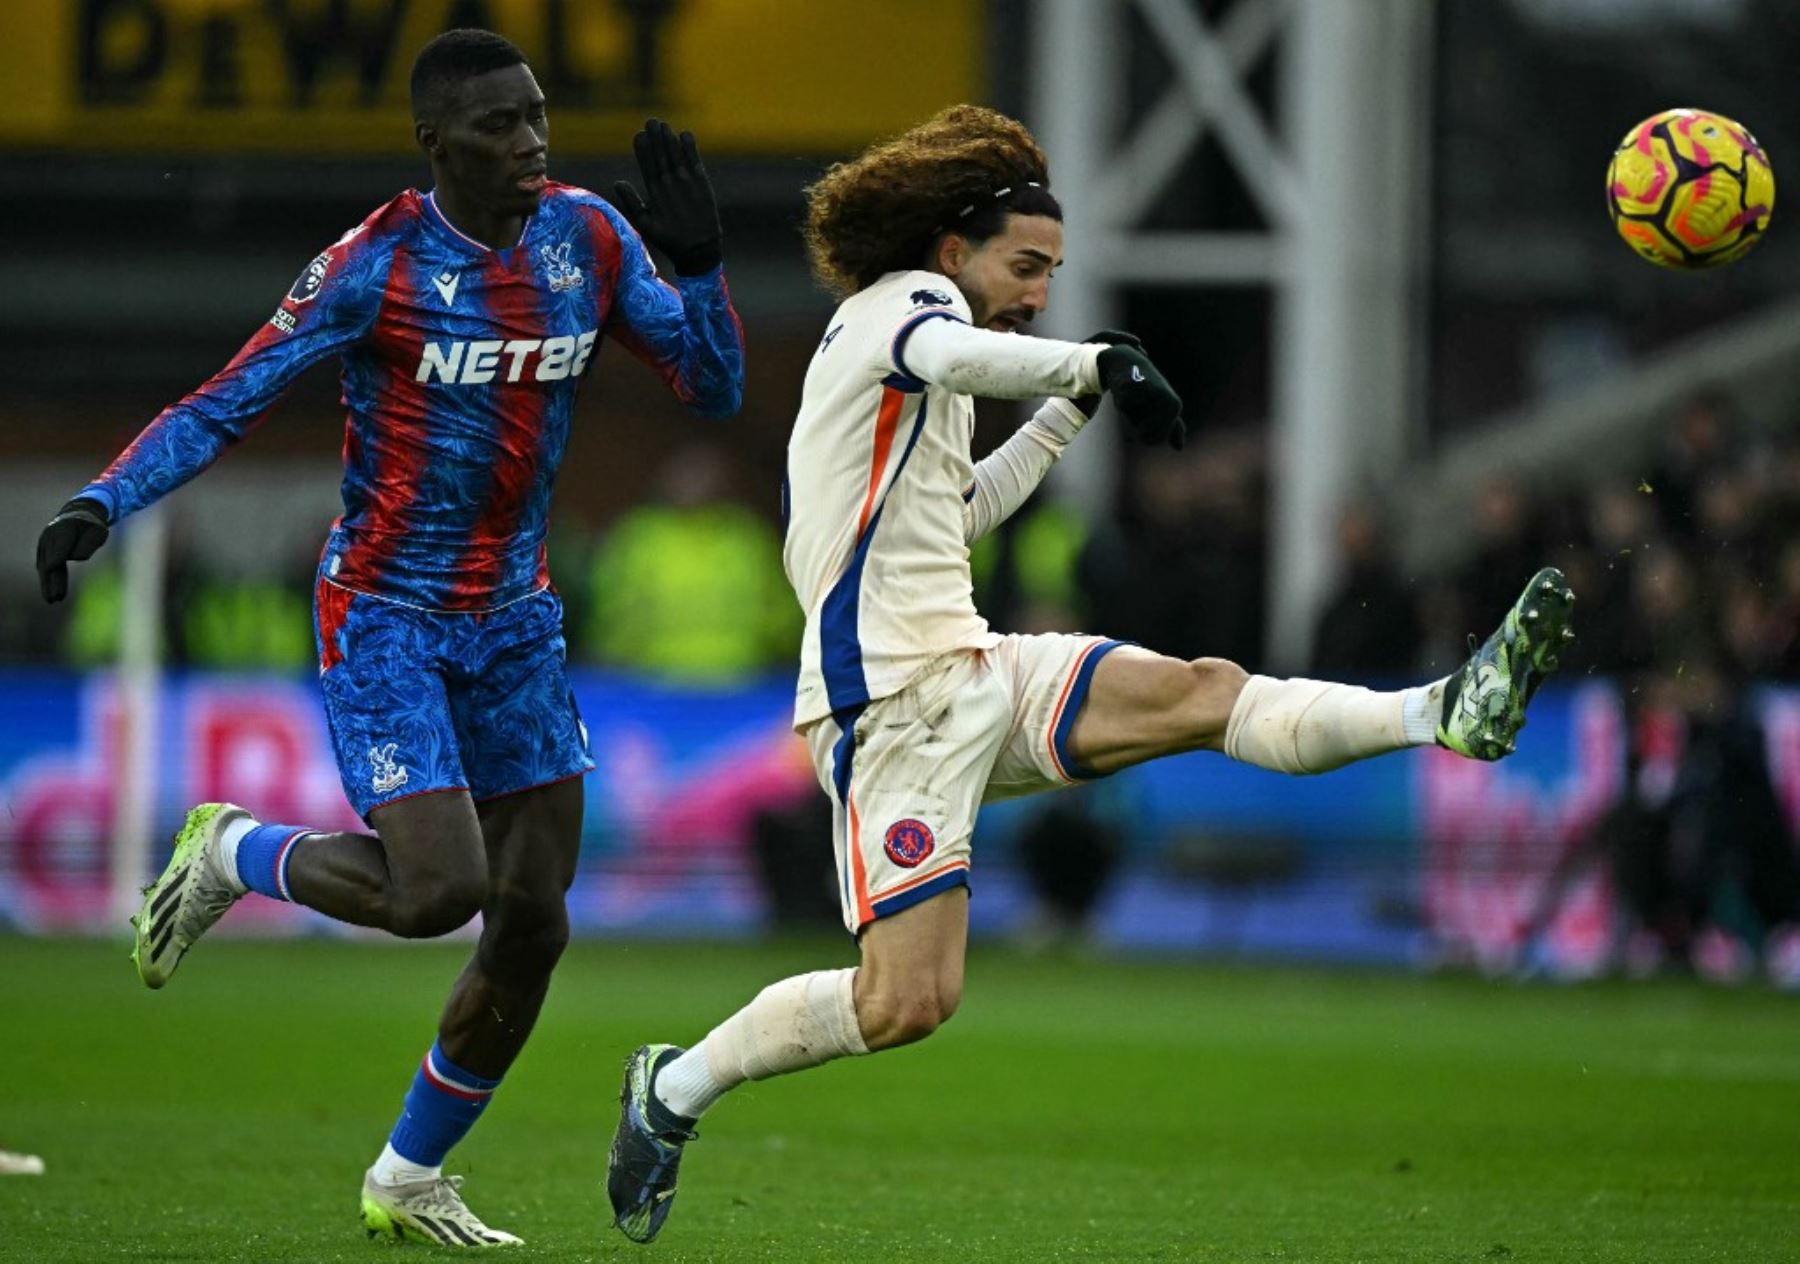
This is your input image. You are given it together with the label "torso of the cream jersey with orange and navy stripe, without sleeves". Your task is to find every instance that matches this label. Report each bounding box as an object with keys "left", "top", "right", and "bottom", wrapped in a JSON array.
[{"left": 785, "top": 272, "right": 999, "bottom": 727}]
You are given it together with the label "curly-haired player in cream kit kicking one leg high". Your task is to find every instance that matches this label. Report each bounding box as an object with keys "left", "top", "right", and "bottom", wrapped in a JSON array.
[{"left": 607, "top": 106, "right": 1573, "bottom": 1242}]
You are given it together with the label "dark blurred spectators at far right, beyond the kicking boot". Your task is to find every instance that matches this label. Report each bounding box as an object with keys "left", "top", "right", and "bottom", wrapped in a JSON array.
[{"left": 1316, "top": 394, "right": 1800, "bottom": 987}]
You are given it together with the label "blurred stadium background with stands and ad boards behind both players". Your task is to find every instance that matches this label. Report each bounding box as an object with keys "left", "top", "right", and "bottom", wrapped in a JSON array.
[{"left": 0, "top": 0, "right": 1800, "bottom": 979}]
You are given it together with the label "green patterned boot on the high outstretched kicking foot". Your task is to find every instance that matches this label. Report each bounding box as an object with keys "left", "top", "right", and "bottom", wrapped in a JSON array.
[{"left": 1438, "top": 565, "right": 1575, "bottom": 760}]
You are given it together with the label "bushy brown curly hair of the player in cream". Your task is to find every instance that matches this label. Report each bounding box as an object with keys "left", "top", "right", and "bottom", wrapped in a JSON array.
[{"left": 805, "top": 104, "right": 1062, "bottom": 299}]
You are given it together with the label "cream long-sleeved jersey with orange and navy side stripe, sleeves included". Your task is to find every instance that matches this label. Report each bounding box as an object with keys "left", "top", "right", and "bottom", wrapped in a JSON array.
[{"left": 783, "top": 272, "right": 1103, "bottom": 727}]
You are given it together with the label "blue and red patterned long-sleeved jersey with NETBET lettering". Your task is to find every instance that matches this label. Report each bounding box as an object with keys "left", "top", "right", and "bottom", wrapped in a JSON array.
[{"left": 79, "top": 184, "right": 743, "bottom": 610}]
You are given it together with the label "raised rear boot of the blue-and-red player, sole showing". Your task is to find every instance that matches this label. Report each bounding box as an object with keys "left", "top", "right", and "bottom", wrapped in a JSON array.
[{"left": 131, "top": 803, "right": 254, "bottom": 987}]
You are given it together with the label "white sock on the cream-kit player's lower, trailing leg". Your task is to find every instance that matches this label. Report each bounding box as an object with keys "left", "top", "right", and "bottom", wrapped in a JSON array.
[{"left": 655, "top": 969, "right": 869, "bottom": 1118}]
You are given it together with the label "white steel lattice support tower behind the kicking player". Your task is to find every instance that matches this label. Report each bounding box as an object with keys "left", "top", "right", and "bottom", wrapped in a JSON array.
[{"left": 1030, "top": 0, "right": 1431, "bottom": 670}]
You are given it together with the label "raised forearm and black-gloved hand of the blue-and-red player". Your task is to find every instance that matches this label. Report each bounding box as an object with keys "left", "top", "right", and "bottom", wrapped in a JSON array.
[{"left": 596, "top": 119, "right": 743, "bottom": 416}]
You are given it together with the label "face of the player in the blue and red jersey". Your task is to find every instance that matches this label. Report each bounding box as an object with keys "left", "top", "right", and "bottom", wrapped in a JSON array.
[{"left": 427, "top": 65, "right": 551, "bottom": 216}]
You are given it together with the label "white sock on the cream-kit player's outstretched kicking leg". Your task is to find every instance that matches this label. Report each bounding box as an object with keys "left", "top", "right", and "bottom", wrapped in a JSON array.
[{"left": 1226, "top": 675, "right": 1444, "bottom": 774}]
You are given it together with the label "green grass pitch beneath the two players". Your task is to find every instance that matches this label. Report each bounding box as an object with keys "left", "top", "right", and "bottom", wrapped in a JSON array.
[{"left": 0, "top": 940, "right": 1800, "bottom": 1264}]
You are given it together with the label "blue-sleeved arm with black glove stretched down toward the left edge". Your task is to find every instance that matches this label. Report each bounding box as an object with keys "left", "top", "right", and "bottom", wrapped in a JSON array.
[{"left": 38, "top": 229, "right": 389, "bottom": 601}]
